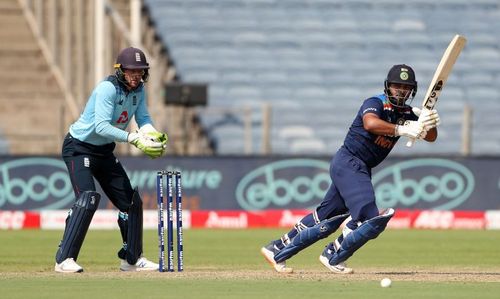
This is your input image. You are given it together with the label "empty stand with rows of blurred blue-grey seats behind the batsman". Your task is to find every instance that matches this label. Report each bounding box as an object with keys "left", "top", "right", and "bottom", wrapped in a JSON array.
[{"left": 146, "top": 0, "right": 500, "bottom": 155}]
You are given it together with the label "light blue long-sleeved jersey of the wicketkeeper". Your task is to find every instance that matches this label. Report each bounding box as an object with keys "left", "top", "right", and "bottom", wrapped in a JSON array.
[{"left": 69, "top": 76, "right": 152, "bottom": 145}]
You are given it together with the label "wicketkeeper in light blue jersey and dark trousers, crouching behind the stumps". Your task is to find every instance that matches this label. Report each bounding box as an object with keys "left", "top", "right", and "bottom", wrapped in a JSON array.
[{"left": 54, "top": 47, "right": 168, "bottom": 273}]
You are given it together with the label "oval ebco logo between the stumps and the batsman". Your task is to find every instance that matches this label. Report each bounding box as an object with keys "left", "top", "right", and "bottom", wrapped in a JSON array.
[{"left": 236, "top": 159, "right": 331, "bottom": 210}]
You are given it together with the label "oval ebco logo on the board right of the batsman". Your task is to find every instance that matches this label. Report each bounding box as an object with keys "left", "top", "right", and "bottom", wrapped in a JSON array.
[{"left": 373, "top": 159, "right": 475, "bottom": 210}]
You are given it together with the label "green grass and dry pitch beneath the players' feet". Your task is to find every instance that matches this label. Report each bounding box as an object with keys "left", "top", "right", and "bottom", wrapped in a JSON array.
[{"left": 0, "top": 229, "right": 500, "bottom": 299}]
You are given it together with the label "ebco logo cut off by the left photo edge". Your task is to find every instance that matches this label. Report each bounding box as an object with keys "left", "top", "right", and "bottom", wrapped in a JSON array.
[{"left": 0, "top": 158, "right": 74, "bottom": 209}]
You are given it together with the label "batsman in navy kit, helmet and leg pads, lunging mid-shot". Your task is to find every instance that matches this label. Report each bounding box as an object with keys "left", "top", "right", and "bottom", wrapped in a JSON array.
[{"left": 261, "top": 64, "right": 440, "bottom": 274}]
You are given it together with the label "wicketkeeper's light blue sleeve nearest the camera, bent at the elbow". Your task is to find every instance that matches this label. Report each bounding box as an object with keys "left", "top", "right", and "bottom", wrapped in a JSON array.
[{"left": 95, "top": 81, "right": 128, "bottom": 142}]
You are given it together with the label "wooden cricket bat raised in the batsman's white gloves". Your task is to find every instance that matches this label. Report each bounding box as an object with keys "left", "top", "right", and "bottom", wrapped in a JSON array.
[{"left": 406, "top": 34, "right": 467, "bottom": 147}]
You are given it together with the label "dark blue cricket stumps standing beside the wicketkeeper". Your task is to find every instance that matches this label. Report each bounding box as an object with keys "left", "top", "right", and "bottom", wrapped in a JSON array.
[{"left": 156, "top": 171, "right": 184, "bottom": 272}]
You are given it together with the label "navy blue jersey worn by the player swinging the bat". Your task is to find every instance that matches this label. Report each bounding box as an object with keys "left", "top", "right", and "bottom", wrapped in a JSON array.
[{"left": 343, "top": 94, "right": 418, "bottom": 168}]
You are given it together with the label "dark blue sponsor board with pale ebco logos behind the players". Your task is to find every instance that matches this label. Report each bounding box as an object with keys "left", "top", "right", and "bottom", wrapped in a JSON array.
[{"left": 0, "top": 157, "right": 500, "bottom": 210}]
